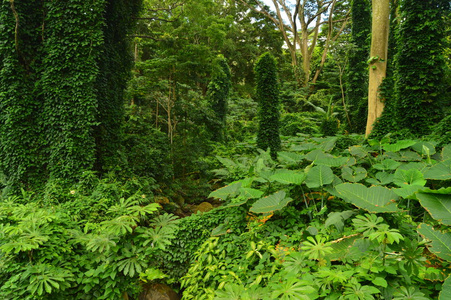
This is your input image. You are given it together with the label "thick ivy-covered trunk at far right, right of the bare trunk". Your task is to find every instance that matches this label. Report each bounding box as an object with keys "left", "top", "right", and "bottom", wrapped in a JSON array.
[{"left": 395, "top": 0, "right": 449, "bottom": 136}]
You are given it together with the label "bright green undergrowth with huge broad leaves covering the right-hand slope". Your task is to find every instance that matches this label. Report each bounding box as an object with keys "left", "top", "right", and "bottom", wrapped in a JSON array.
[{"left": 181, "top": 137, "right": 451, "bottom": 300}]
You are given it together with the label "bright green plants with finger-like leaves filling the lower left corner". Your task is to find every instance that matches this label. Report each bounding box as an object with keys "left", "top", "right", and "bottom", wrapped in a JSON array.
[{"left": 0, "top": 177, "right": 179, "bottom": 300}]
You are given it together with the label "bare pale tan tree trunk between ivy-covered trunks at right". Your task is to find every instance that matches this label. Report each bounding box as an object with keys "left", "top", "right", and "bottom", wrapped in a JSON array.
[{"left": 365, "top": 0, "right": 390, "bottom": 137}]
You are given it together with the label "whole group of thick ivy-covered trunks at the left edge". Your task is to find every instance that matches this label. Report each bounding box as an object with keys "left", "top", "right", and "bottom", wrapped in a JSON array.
[{"left": 0, "top": 0, "right": 140, "bottom": 192}]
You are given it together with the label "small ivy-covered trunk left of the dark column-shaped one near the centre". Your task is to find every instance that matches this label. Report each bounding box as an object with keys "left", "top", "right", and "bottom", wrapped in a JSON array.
[{"left": 208, "top": 55, "right": 231, "bottom": 141}]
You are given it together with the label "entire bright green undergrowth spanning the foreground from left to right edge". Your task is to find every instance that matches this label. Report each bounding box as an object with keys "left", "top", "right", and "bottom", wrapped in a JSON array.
[{"left": 0, "top": 136, "right": 451, "bottom": 300}]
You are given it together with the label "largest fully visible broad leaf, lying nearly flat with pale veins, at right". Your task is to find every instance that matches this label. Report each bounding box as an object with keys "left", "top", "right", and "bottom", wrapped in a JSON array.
[{"left": 335, "top": 183, "right": 400, "bottom": 213}]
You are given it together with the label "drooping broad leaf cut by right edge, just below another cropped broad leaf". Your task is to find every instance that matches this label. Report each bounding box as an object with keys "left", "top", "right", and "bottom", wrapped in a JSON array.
[{"left": 418, "top": 223, "right": 451, "bottom": 262}]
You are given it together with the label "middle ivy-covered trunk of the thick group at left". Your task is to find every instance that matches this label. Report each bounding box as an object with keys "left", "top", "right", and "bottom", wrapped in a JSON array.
[{"left": 39, "top": 0, "right": 105, "bottom": 180}]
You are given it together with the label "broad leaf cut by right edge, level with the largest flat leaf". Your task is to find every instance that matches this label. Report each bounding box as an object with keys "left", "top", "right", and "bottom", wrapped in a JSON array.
[{"left": 417, "top": 193, "right": 451, "bottom": 225}]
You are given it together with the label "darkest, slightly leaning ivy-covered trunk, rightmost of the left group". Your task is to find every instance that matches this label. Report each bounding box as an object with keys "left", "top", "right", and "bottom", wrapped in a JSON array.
[{"left": 95, "top": 0, "right": 142, "bottom": 171}]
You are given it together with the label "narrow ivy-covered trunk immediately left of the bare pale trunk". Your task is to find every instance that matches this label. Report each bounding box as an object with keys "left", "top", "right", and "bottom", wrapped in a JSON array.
[{"left": 346, "top": 0, "right": 371, "bottom": 133}]
